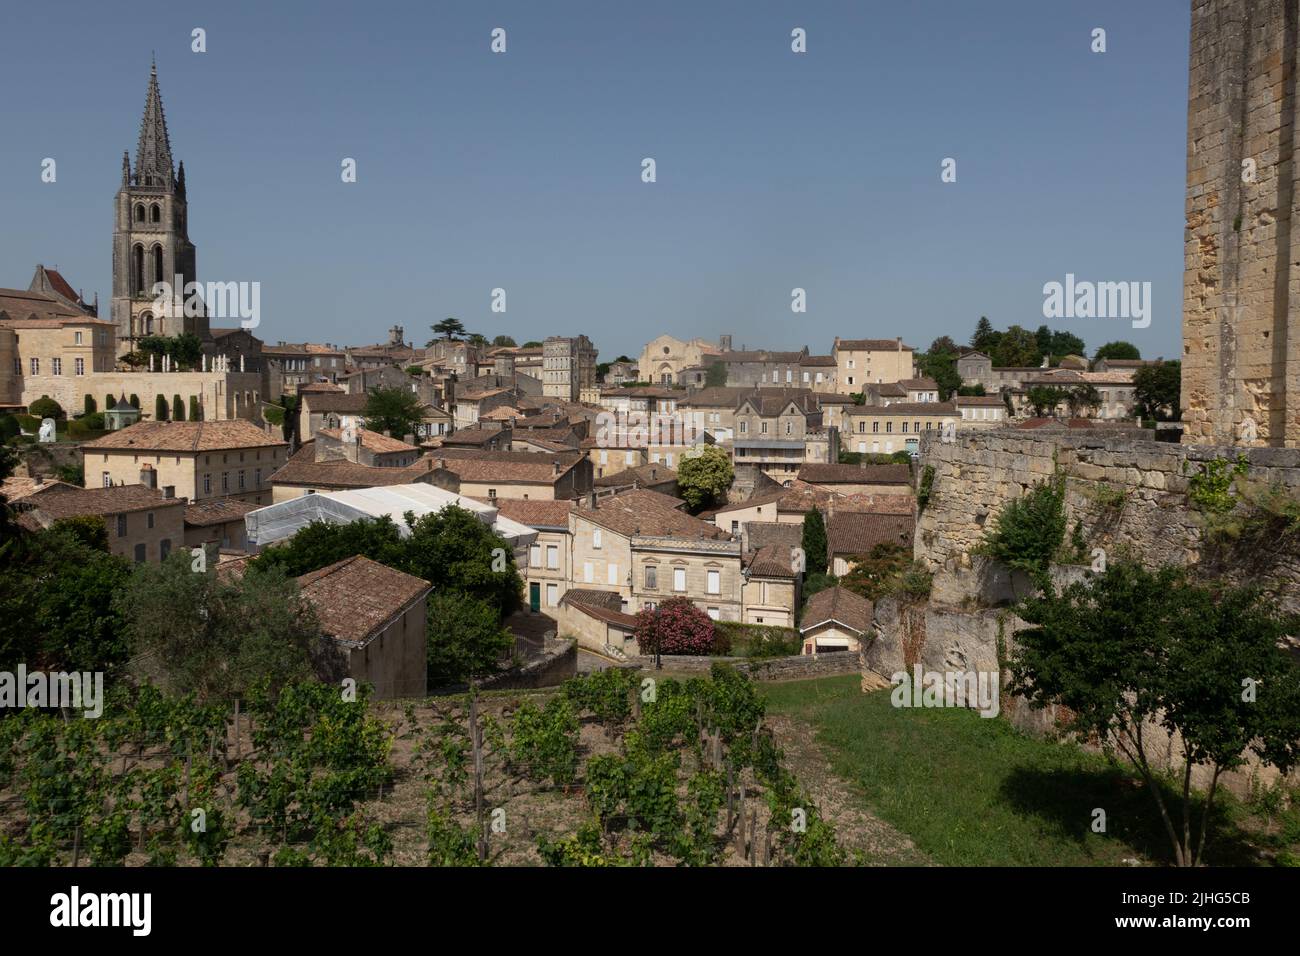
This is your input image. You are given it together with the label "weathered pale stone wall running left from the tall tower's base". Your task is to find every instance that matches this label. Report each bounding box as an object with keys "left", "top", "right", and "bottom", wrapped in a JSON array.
[{"left": 915, "top": 429, "right": 1300, "bottom": 611}]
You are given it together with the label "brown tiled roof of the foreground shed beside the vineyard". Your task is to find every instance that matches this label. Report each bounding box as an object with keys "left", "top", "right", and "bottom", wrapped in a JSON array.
[{"left": 298, "top": 554, "right": 432, "bottom": 646}]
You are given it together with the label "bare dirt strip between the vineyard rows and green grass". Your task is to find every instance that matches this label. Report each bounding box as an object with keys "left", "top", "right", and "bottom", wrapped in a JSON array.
[{"left": 767, "top": 714, "right": 933, "bottom": 866}]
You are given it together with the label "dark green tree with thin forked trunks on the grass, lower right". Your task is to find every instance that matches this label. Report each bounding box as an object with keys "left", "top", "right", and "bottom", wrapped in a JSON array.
[{"left": 1009, "top": 562, "right": 1300, "bottom": 866}]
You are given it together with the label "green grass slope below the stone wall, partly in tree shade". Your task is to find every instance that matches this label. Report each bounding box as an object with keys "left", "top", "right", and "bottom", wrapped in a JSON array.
[{"left": 759, "top": 674, "right": 1258, "bottom": 866}]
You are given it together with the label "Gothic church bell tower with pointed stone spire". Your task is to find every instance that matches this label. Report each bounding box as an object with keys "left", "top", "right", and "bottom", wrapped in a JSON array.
[{"left": 113, "top": 65, "right": 211, "bottom": 355}]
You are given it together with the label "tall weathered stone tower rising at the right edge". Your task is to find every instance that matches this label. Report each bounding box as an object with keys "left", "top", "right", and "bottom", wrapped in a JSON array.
[{"left": 1183, "top": 0, "right": 1300, "bottom": 447}]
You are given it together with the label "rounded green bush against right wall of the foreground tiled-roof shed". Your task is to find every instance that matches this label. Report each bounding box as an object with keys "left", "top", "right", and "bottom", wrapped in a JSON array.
[{"left": 428, "top": 591, "right": 515, "bottom": 688}]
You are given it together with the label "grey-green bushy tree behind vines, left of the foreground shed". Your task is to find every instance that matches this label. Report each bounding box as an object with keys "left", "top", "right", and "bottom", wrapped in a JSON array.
[{"left": 117, "top": 550, "right": 332, "bottom": 700}]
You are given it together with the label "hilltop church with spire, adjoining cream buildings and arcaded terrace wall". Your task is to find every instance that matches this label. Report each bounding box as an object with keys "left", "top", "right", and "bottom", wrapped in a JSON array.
[{"left": 0, "top": 65, "right": 265, "bottom": 421}]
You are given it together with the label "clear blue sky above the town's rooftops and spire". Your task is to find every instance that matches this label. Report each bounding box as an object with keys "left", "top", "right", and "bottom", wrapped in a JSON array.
[{"left": 0, "top": 0, "right": 1190, "bottom": 359}]
